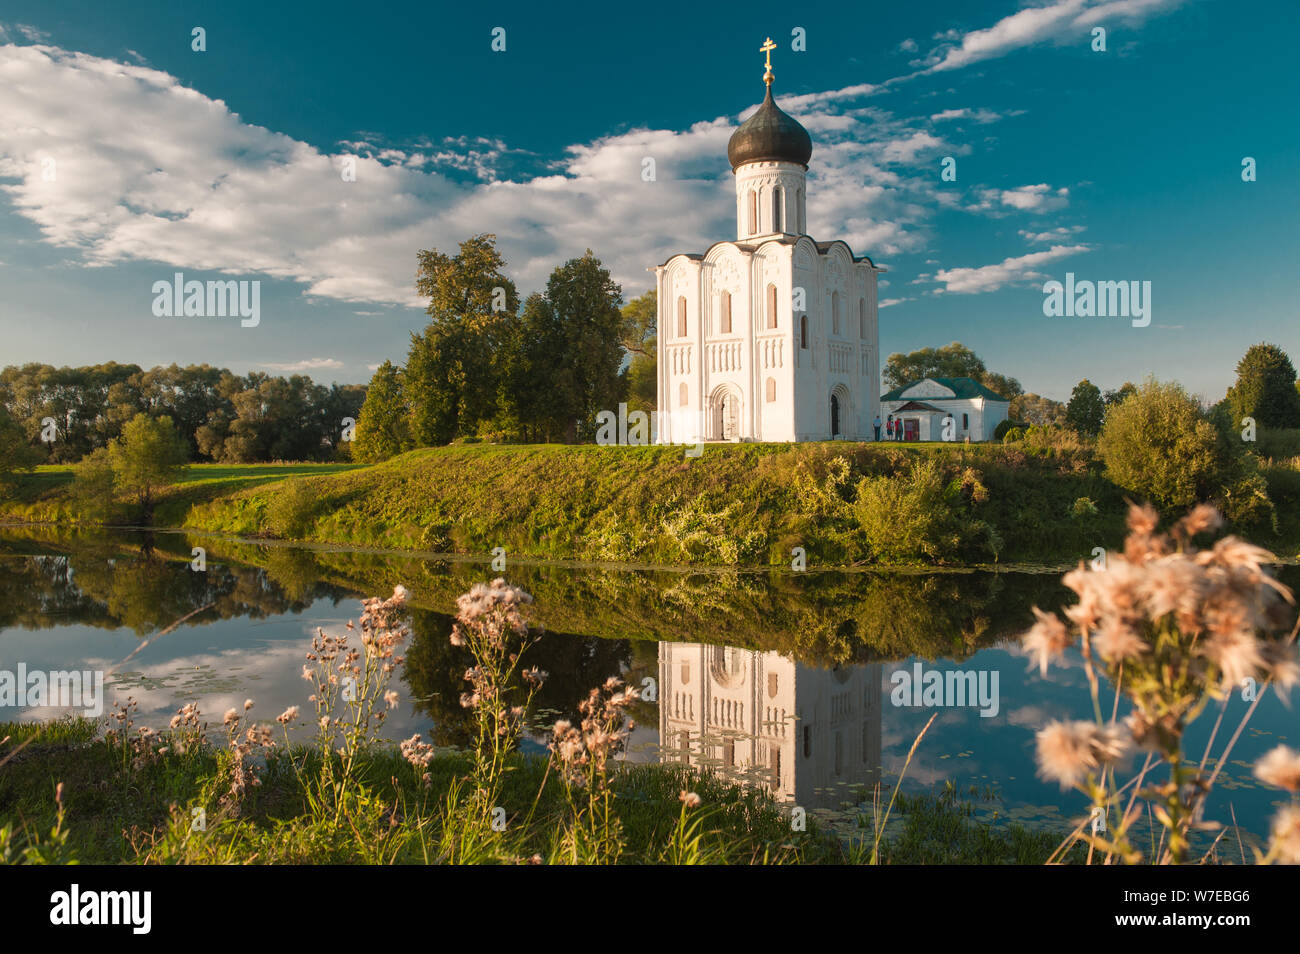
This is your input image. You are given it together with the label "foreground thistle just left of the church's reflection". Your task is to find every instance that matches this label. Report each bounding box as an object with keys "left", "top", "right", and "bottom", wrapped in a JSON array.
[{"left": 550, "top": 676, "right": 637, "bottom": 864}]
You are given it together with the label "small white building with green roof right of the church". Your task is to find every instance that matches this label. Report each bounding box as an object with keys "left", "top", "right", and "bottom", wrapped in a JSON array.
[{"left": 880, "top": 378, "right": 1011, "bottom": 442}]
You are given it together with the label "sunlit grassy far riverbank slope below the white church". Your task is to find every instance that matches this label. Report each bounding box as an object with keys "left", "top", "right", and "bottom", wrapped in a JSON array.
[{"left": 0, "top": 442, "right": 1300, "bottom": 568}]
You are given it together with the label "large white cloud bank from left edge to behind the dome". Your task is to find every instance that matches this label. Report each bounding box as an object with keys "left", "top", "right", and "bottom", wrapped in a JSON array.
[{"left": 0, "top": 45, "right": 961, "bottom": 307}]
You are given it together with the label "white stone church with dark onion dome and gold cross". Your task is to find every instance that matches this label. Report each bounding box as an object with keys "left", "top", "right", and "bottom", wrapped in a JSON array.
[{"left": 655, "top": 43, "right": 884, "bottom": 443}]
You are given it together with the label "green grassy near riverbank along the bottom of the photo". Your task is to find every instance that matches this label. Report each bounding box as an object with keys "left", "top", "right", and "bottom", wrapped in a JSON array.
[{"left": 0, "top": 720, "right": 1058, "bottom": 864}]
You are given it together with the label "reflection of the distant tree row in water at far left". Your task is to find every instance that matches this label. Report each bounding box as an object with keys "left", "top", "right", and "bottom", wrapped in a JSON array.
[{"left": 0, "top": 547, "right": 354, "bottom": 636}]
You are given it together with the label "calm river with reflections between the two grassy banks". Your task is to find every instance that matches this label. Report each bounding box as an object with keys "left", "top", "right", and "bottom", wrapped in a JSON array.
[{"left": 0, "top": 528, "right": 1300, "bottom": 834}]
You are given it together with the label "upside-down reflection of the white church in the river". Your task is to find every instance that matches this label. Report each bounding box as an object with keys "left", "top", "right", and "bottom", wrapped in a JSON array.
[{"left": 659, "top": 642, "right": 881, "bottom": 808}]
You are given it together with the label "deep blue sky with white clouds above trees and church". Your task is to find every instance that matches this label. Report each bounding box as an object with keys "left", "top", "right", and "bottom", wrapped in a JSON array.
[{"left": 0, "top": 0, "right": 1300, "bottom": 399}]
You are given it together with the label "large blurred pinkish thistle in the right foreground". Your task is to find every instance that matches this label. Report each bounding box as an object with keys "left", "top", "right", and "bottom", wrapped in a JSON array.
[{"left": 1024, "top": 504, "right": 1300, "bottom": 864}]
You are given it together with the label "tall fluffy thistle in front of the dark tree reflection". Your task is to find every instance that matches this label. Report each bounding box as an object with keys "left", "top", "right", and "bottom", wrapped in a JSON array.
[{"left": 450, "top": 578, "right": 546, "bottom": 818}]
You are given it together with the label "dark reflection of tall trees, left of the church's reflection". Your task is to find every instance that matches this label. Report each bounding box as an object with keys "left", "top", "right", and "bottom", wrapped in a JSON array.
[{"left": 403, "top": 610, "right": 631, "bottom": 746}]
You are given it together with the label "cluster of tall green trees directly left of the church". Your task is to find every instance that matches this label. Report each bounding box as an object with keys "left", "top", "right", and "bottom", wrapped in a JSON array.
[{"left": 354, "top": 234, "right": 657, "bottom": 461}]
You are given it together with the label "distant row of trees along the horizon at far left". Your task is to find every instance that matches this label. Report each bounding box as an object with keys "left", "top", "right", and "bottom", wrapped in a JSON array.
[{"left": 0, "top": 361, "right": 365, "bottom": 464}]
